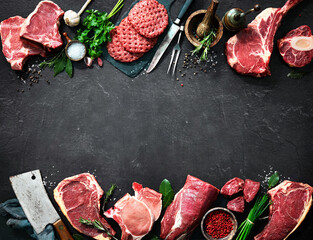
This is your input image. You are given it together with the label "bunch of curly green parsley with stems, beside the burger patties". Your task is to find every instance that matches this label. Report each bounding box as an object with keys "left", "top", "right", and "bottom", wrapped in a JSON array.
[{"left": 75, "top": 0, "right": 124, "bottom": 59}]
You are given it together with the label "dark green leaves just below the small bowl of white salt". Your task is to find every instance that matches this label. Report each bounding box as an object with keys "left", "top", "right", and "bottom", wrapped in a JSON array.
[{"left": 39, "top": 49, "right": 73, "bottom": 77}]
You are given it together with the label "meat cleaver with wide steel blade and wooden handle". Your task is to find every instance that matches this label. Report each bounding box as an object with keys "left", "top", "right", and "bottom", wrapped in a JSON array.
[{"left": 10, "top": 170, "right": 73, "bottom": 240}]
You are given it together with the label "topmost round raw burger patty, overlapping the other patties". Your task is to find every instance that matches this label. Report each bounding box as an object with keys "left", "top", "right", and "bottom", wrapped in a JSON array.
[{"left": 128, "top": 0, "right": 168, "bottom": 38}]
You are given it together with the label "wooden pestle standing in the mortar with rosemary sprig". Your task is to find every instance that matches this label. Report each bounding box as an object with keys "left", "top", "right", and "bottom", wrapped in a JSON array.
[{"left": 196, "top": 0, "right": 219, "bottom": 38}]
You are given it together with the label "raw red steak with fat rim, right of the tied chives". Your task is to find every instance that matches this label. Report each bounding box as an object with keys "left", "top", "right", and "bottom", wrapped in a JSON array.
[{"left": 254, "top": 180, "right": 313, "bottom": 240}]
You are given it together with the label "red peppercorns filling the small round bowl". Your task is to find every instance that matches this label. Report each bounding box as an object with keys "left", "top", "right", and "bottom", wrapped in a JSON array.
[{"left": 204, "top": 210, "right": 234, "bottom": 238}]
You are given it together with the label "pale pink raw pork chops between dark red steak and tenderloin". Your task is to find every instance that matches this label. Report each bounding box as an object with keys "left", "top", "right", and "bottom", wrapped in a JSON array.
[{"left": 104, "top": 182, "right": 162, "bottom": 240}]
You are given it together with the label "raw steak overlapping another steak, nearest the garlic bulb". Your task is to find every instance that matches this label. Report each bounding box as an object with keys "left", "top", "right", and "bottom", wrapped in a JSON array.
[{"left": 21, "top": 1, "right": 64, "bottom": 51}]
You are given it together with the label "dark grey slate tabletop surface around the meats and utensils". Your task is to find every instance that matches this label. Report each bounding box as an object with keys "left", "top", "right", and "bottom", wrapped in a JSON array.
[{"left": 0, "top": 0, "right": 313, "bottom": 240}]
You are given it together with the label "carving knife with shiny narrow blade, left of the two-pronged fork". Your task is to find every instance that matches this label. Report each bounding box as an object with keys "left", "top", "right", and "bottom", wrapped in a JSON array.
[{"left": 147, "top": 0, "right": 193, "bottom": 73}]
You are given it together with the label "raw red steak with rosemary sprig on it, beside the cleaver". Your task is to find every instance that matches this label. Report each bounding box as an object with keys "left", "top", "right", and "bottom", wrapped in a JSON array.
[{"left": 53, "top": 173, "right": 115, "bottom": 240}]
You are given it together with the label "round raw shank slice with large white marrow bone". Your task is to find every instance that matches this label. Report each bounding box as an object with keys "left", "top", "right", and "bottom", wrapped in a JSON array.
[{"left": 277, "top": 25, "right": 313, "bottom": 67}]
